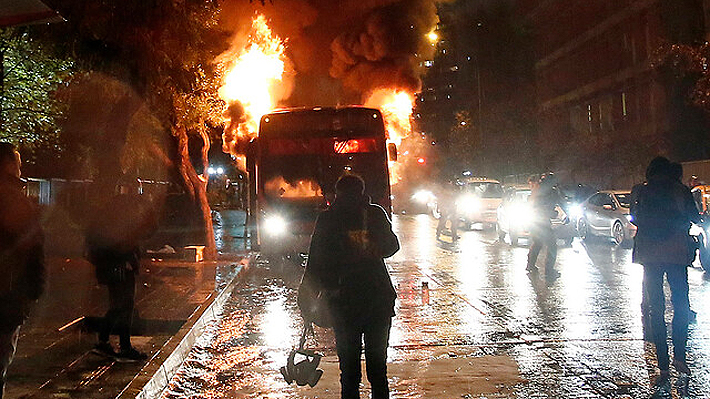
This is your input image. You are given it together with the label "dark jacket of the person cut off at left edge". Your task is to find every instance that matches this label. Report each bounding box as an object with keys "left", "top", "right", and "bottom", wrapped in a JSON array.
[{"left": 0, "top": 176, "right": 45, "bottom": 332}]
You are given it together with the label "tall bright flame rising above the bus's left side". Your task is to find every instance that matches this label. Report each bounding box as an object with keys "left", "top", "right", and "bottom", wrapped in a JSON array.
[{"left": 219, "top": 15, "right": 288, "bottom": 155}]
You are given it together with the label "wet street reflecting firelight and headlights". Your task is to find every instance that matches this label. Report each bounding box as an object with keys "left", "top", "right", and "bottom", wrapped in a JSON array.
[{"left": 163, "top": 215, "right": 710, "bottom": 398}]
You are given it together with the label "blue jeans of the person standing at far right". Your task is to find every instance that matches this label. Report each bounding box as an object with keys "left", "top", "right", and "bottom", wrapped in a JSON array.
[{"left": 643, "top": 264, "right": 690, "bottom": 370}]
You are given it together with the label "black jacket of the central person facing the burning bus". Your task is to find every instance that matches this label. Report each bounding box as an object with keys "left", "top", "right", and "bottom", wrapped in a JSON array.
[{"left": 304, "top": 201, "right": 399, "bottom": 322}]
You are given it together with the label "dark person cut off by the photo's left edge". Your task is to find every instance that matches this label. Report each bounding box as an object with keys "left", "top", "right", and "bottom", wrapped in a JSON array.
[{"left": 0, "top": 142, "right": 44, "bottom": 399}]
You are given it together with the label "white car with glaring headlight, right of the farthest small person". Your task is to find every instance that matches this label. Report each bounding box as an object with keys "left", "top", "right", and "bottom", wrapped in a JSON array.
[{"left": 456, "top": 177, "right": 503, "bottom": 228}]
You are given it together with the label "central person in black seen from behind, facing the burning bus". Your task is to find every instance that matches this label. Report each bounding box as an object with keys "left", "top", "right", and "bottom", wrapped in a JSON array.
[{"left": 304, "top": 174, "right": 399, "bottom": 399}]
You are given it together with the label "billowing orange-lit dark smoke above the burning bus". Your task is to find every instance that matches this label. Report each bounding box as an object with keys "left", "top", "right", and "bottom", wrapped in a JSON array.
[{"left": 222, "top": 0, "right": 437, "bottom": 106}]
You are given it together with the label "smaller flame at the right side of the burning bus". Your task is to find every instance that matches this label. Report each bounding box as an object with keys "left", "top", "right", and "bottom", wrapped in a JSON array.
[{"left": 365, "top": 89, "right": 414, "bottom": 185}]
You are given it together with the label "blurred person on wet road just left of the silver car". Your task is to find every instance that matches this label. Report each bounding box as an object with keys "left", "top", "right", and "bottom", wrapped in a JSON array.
[{"left": 527, "top": 173, "right": 562, "bottom": 278}]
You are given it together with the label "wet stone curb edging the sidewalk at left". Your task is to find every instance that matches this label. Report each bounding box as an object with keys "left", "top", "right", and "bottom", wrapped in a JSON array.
[{"left": 116, "top": 258, "right": 250, "bottom": 399}]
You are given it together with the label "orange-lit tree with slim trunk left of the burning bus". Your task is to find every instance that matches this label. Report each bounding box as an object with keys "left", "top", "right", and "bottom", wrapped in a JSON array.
[{"left": 48, "top": 0, "right": 227, "bottom": 257}]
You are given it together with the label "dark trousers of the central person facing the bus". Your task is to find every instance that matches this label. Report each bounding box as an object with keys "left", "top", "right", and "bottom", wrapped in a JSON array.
[{"left": 334, "top": 317, "right": 392, "bottom": 399}]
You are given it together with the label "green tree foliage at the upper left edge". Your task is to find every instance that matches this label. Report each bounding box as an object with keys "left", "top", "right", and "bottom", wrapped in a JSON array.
[{"left": 0, "top": 28, "right": 73, "bottom": 148}]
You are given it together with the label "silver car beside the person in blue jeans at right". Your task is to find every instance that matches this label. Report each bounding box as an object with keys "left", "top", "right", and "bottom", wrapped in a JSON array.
[{"left": 577, "top": 190, "right": 636, "bottom": 245}]
